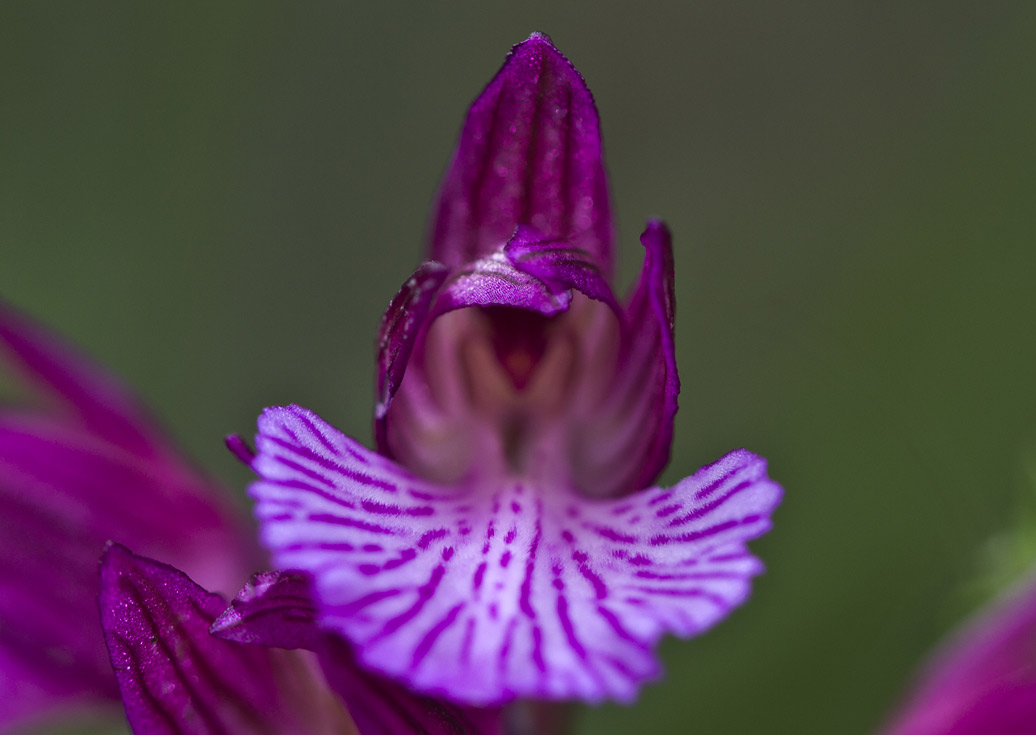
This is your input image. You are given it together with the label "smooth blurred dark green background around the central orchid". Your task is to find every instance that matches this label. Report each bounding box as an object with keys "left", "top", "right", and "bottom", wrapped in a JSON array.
[{"left": 0, "top": 0, "right": 1036, "bottom": 735}]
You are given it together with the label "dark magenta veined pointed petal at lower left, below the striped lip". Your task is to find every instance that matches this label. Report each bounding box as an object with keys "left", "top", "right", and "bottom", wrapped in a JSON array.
[{"left": 99, "top": 544, "right": 357, "bottom": 735}]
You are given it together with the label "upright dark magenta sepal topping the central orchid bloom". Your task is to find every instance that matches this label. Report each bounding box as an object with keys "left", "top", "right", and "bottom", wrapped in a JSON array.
[{"left": 431, "top": 33, "right": 613, "bottom": 277}]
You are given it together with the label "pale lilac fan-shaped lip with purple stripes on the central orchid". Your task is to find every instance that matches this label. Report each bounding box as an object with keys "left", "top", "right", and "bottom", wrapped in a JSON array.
[{"left": 250, "top": 406, "right": 781, "bottom": 705}]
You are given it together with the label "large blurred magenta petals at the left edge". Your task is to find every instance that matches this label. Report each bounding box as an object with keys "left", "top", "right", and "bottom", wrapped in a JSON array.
[{"left": 0, "top": 303, "right": 259, "bottom": 732}]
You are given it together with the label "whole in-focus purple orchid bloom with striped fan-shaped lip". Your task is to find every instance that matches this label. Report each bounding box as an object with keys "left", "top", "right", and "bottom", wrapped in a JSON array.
[{"left": 235, "top": 34, "right": 781, "bottom": 705}]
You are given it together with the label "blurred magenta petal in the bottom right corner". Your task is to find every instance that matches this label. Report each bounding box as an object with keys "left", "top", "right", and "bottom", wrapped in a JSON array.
[{"left": 885, "top": 577, "right": 1036, "bottom": 735}]
